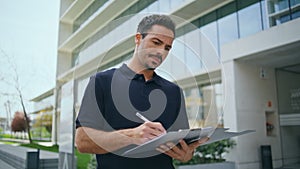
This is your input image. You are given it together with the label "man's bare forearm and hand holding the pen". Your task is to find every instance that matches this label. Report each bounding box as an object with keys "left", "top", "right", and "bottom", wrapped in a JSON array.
[{"left": 75, "top": 122, "right": 166, "bottom": 154}]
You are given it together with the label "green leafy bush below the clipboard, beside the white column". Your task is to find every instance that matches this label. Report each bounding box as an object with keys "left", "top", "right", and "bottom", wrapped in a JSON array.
[{"left": 173, "top": 139, "right": 236, "bottom": 166}]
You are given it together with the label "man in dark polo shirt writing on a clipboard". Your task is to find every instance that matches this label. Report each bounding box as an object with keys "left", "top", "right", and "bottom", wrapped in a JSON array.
[{"left": 76, "top": 15, "right": 206, "bottom": 169}]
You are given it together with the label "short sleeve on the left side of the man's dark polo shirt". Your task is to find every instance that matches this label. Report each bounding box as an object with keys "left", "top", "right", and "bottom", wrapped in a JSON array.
[{"left": 76, "top": 76, "right": 104, "bottom": 130}]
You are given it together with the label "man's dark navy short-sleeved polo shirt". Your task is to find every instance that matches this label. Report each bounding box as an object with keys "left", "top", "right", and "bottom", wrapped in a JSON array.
[{"left": 76, "top": 64, "right": 189, "bottom": 169}]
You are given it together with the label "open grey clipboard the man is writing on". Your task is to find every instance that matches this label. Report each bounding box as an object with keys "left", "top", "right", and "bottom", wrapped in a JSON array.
[{"left": 122, "top": 127, "right": 254, "bottom": 158}]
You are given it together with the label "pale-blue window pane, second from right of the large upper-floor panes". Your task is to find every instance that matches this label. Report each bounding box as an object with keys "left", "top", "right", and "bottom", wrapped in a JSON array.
[{"left": 218, "top": 13, "right": 238, "bottom": 46}]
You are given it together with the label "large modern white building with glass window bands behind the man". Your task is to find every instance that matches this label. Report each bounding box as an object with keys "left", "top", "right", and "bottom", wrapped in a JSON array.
[{"left": 54, "top": 0, "right": 300, "bottom": 169}]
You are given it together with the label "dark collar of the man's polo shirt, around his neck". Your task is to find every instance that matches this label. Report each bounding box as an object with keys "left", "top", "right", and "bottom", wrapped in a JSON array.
[{"left": 119, "top": 64, "right": 163, "bottom": 85}]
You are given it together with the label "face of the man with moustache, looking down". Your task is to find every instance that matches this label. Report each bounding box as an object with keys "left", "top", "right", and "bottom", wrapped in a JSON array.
[{"left": 136, "top": 25, "right": 174, "bottom": 69}]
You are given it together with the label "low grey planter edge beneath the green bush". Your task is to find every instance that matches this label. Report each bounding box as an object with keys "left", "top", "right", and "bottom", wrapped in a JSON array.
[{"left": 176, "top": 161, "right": 235, "bottom": 169}]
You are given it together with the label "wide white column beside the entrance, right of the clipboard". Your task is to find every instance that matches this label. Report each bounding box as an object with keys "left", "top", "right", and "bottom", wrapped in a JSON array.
[{"left": 222, "top": 60, "right": 282, "bottom": 169}]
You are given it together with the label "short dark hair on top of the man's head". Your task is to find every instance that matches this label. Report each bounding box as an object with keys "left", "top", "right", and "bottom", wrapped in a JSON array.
[{"left": 137, "top": 14, "right": 175, "bottom": 38}]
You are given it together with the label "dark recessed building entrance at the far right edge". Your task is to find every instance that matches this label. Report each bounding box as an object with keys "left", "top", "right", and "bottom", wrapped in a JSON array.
[{"left": 276, "top": 63, "right": 300, "bottom": 168}]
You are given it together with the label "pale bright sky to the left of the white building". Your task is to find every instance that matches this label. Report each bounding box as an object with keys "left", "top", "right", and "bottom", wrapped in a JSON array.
[{"left": 0, "top": 0, "right": 60, "bottom": 117}]
